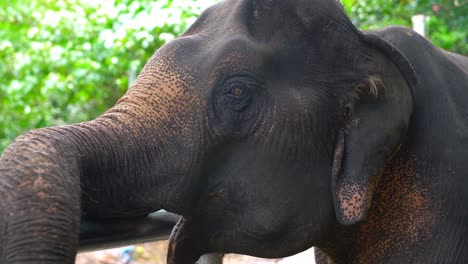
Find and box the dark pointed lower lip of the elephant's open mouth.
[167,218,206,264]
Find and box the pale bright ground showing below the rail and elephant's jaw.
[76,241,315,264]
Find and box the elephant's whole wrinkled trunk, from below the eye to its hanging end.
[0,81,203,263]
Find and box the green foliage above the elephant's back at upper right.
[341,0,468,55]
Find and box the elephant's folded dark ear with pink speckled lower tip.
[332,75,412,225]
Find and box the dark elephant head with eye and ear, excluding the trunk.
[168,0,416,263]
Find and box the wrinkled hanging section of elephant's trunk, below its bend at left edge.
[0,128,80,263]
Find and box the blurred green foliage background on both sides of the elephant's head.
[0,0,468,153]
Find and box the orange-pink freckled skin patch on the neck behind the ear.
[358,155,438,263]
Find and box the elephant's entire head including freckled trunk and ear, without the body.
[0,0,413,263]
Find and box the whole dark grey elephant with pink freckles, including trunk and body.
[0,0,468,264]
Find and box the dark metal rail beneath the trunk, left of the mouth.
[79,211,179,252]
